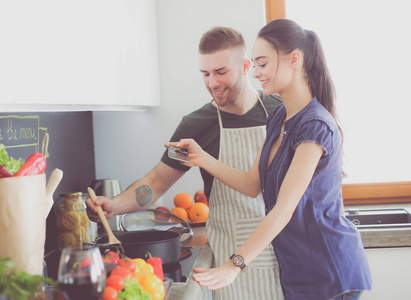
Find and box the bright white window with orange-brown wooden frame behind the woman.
[267,0,411,202]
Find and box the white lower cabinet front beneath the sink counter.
[361,247,411,300]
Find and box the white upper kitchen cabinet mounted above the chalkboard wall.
[0,0,160,111]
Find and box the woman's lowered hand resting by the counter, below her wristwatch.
[193,260,241,290]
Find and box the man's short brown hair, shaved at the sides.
[198,26,245,54]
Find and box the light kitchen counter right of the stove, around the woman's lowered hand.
[168,227,213,300]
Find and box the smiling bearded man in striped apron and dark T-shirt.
[87,27,283,300]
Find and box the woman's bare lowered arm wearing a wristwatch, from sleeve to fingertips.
[193,143,323,289]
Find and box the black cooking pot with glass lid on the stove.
[96,209,193,265]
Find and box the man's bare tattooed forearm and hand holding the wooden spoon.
[86,161,185,221]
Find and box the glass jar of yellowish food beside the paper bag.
[55,192,93,248]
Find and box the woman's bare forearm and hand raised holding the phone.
[165,139,261,198]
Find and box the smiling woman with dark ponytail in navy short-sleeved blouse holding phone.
[170,19,371,300]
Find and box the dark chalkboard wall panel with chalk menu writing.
[0,112,95,252]
